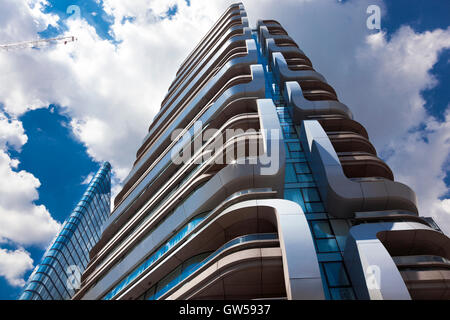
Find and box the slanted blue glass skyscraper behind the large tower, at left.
[19,162,111,300]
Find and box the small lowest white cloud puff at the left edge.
[0,248,33,287]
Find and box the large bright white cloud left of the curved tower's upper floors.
[0,0,226,180]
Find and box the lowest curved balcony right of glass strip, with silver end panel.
[344,222,450,300]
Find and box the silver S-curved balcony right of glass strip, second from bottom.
[301,120,418,218]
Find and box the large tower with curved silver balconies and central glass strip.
[74,4,450,300]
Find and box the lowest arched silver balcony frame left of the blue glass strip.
[93,199,324,299]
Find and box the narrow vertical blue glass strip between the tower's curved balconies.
[254,33,355,300]
